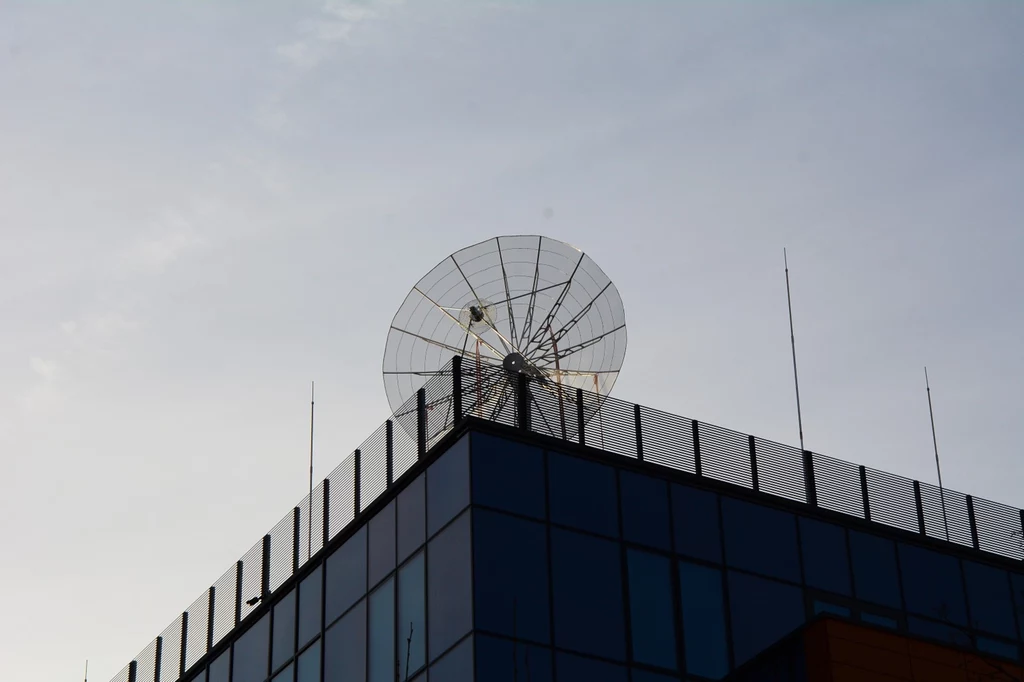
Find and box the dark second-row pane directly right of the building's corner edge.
[473,510,551,643]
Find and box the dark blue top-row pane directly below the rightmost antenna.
[899,543,967,625]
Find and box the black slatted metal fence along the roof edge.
[112,357,1024,682]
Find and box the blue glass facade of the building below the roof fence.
[196,432,1024,682]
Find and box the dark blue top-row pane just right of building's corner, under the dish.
[472,433,544,520]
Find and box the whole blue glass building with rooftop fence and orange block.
[105,364,1024,682]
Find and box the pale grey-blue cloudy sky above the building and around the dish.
[6,0,1024,682]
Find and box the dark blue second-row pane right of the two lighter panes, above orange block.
[729,570,804,666]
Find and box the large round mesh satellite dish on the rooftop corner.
[383,236,626,440]
